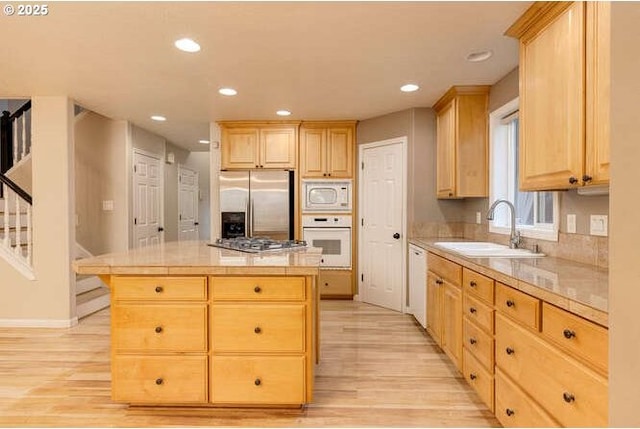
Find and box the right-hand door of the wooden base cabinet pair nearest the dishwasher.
[442,281,462,371]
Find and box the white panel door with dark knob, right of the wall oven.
[360,142,404,311]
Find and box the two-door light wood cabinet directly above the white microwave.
[300,121,356,178]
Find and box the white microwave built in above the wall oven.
[302,179,352,213]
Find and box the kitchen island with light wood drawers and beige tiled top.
[74,241,321,407]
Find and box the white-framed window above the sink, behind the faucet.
[489,98,558,241]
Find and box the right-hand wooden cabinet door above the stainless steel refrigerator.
[259,127,297,168]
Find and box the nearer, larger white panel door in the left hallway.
[133,152,164,247]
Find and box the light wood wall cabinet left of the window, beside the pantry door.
[433,85,490,198]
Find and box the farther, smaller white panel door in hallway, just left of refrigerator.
[178,167,198,241]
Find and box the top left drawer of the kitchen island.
[111,276,207,301]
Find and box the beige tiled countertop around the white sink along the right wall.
[409,238,609,326]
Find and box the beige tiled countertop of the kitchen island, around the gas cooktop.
[73,241,322,275]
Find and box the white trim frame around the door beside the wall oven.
[353,136,408,313]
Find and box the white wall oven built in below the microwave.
[302,215,351,270]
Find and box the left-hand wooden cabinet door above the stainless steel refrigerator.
[221,128,259,169]
